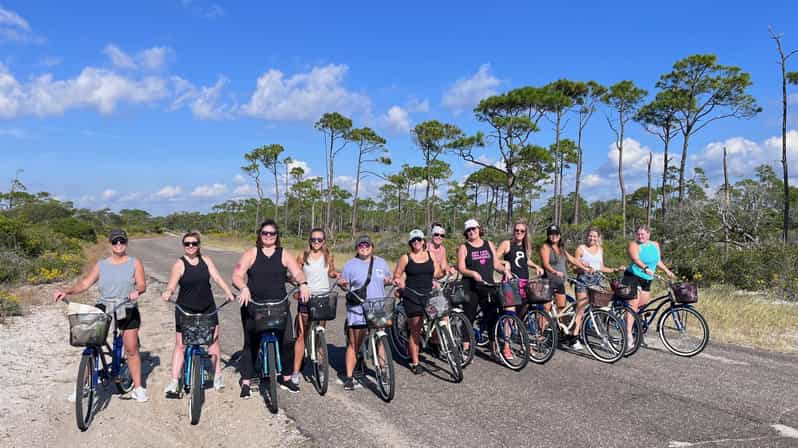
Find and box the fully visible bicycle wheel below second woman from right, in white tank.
[581,307,626,363]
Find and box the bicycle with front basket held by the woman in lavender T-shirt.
[341,286,396,402]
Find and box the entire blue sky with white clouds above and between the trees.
[0,0,798,214]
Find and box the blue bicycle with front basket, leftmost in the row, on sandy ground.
[63,298,133,431]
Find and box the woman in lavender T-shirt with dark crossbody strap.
[339,235,391,390]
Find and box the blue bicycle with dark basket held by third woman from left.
[248,286,298,414]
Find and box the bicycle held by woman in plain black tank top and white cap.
[391,288,463,383]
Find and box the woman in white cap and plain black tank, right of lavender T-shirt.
[393,229,441,375]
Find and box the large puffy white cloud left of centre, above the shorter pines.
[241,64,371,120]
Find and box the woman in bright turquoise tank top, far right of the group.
[621,225,674,340]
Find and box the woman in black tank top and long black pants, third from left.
[233,219,310,399]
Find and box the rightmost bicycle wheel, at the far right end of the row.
[657,306,709,357]
